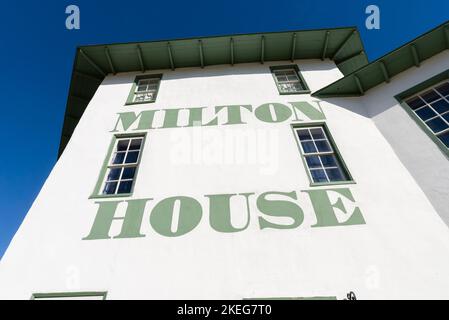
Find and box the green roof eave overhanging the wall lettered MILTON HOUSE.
[59,27,368,155]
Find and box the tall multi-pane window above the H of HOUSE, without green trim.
[102,137,143,195]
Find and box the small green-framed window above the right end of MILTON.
[271,65,310,94]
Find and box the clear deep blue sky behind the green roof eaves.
[0,0,449,257]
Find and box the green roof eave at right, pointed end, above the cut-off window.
[312,22,449,98]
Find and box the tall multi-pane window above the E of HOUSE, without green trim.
[294,125,352,184]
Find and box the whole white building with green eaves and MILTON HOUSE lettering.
[0,23,449,299]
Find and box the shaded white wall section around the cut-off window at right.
[363,50,449,225]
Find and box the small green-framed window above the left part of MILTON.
[126,74,162,104]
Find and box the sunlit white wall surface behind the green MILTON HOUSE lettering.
[0,61,449,299]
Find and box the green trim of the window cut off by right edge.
[395,69,449,159]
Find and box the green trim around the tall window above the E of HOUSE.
[290,121,356,187]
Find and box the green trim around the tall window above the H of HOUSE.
[89,132,147,199]
